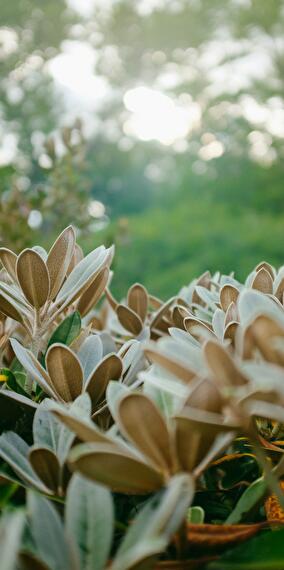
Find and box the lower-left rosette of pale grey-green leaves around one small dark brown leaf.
[0,395,91,497]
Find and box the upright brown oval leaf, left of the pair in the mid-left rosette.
[46,344,83,402]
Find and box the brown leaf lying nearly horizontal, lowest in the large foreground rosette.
[69,443,164,494]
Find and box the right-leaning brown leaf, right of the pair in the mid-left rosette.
[85,354,123,406]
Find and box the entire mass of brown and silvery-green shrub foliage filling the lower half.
[0,227,284,570]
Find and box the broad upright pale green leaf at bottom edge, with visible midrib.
[65,475,114,570]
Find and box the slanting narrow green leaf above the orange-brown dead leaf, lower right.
[226,477,267,524]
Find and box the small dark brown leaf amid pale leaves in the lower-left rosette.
[29,447,60,493]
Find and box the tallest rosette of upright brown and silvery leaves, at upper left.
[0,226,113,390]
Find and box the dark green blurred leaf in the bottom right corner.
[208,529,284,570]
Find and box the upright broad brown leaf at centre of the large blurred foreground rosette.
[117,393,175,472]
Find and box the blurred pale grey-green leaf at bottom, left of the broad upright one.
[27,491,76,570]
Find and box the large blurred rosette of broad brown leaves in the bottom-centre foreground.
[53,385,235,494]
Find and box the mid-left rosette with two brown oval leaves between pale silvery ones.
[11,334,144,419]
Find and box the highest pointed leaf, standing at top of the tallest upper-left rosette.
[46,226,76,300]
